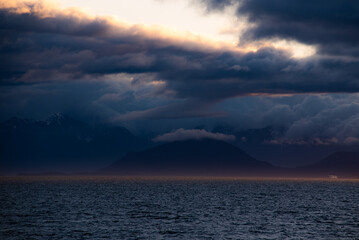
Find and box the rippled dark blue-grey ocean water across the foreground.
[0,179,359,240]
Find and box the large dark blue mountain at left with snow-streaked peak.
[0,114,147,172]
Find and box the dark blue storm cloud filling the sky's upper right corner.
[201,0,359,57]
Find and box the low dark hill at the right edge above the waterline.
[295,152,359,178]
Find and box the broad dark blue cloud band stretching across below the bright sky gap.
[0,2,359,96]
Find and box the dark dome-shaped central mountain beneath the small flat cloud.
[104,139,279,176]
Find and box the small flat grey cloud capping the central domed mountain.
[153,128,236,142]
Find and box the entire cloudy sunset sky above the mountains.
[0,0,359,165]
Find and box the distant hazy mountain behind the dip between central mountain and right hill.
[212,125,358,168]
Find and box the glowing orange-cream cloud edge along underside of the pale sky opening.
[0,0,315,58]
